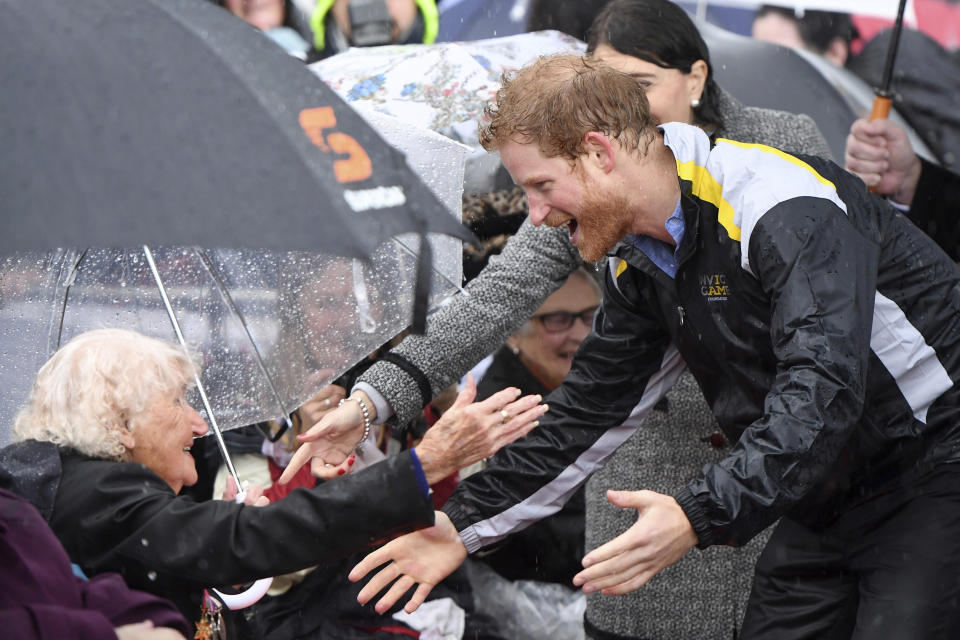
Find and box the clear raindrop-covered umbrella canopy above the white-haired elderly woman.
[0,239,456,444]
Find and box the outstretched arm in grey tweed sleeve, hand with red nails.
[280,221,583,482]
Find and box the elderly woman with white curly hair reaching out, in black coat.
[0,329,546,632]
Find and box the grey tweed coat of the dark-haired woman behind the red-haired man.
[358,91,831,640]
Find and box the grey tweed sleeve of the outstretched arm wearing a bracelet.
[357,219,583,427]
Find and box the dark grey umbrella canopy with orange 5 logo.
[0,0,468,257]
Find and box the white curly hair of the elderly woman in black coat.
[13,329,196,461]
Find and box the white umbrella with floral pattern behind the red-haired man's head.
[310,31,586,147]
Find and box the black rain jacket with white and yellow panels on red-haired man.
[444,123,960,551]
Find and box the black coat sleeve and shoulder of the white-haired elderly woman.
[0,443,433,617]
